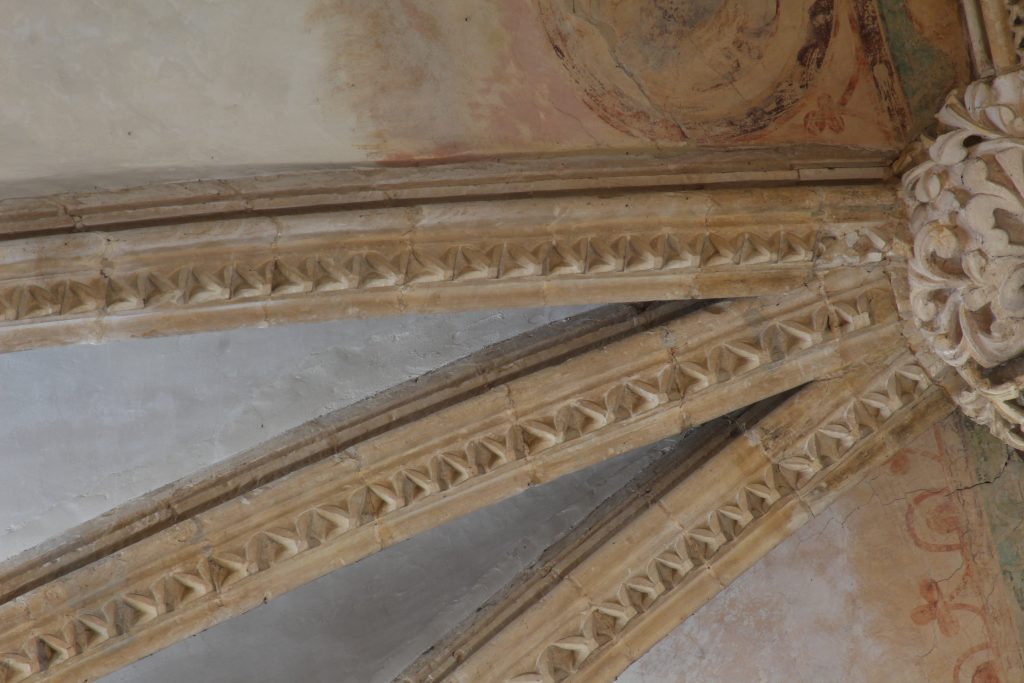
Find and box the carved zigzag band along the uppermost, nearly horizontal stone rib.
[0,231,816,322]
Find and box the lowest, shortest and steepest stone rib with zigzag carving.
[396,351,952,683]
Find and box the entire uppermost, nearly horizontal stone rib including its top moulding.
[0,147,899,352]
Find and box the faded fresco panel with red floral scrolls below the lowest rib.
[620,416,1024,683]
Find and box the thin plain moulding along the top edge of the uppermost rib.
[0,145,892,241]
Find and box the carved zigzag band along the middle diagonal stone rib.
[0,290,892,683]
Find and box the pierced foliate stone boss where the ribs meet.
[903,65,1024,449]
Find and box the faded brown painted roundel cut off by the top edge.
[538,0,836,141]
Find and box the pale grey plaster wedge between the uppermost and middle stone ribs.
[0,308,582,560]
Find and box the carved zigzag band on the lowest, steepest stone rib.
[509,365,931,683]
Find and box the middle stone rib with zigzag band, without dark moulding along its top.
[0,268,902,683]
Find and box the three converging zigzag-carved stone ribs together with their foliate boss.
[0,3,1024,683]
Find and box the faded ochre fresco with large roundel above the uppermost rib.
[308,0,969,159]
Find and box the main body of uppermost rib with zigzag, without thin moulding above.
[0,179,897,352]
